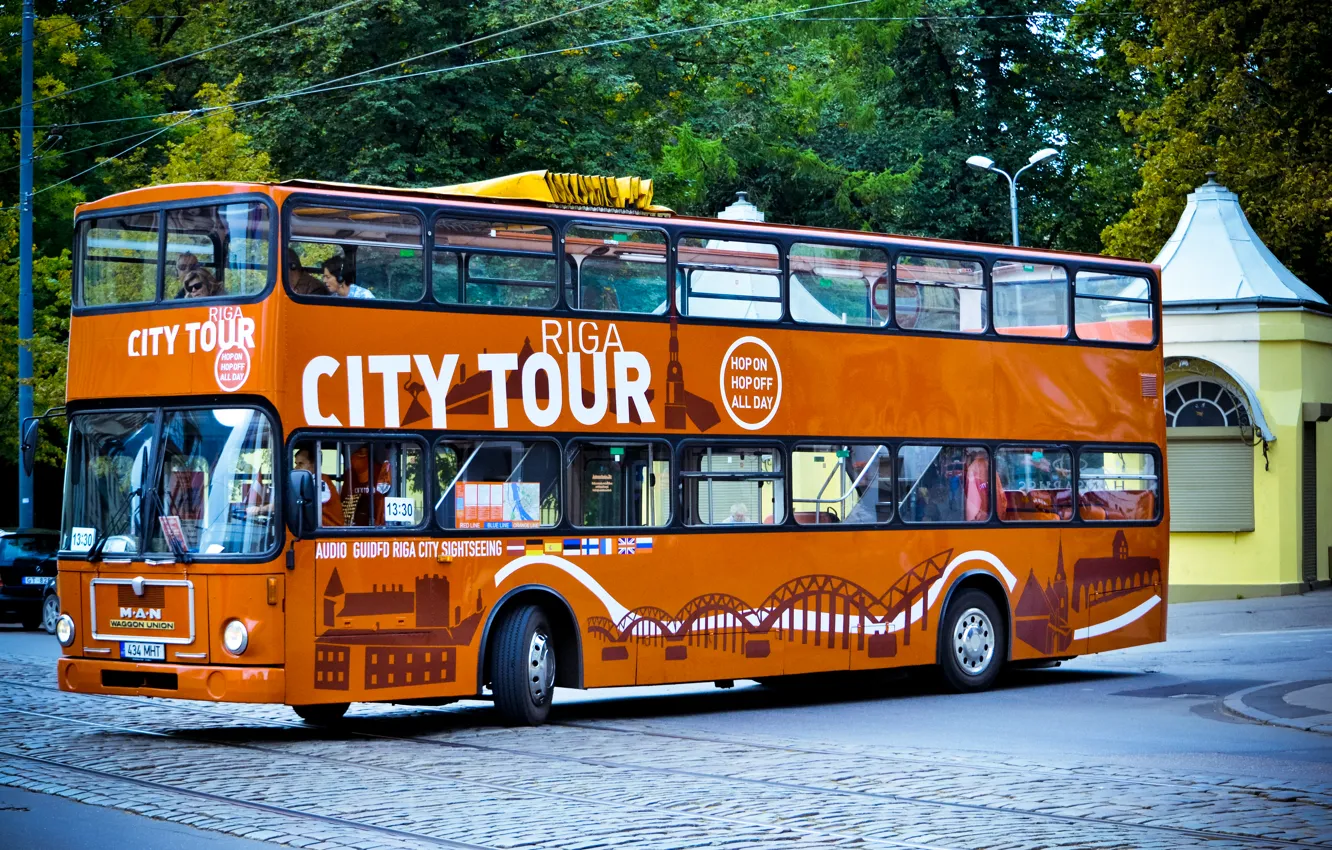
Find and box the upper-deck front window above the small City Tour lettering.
[79,203,270,306]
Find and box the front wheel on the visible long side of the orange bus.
[489,605,555,726]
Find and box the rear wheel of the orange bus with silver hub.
[939,588,1008,693]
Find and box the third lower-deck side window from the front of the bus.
[569,442,670,528]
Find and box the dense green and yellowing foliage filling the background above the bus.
[0,0,1332,482]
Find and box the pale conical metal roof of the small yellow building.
[1154,175,1327,304]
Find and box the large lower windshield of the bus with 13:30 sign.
[61,408,280,556]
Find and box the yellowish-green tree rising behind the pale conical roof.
[1103,0,1332,300]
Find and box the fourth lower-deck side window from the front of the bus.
[681,445,786,525]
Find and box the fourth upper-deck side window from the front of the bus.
[677,236,782,321]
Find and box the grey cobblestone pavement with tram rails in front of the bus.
[0,654,1332,850]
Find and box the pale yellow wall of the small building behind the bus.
[1166,310,1332,600]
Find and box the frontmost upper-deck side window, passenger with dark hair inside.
[288,205,425,301]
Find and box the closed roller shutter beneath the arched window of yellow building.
[1166,437,1253,532]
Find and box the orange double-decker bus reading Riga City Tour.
[44,172,1167,723]
